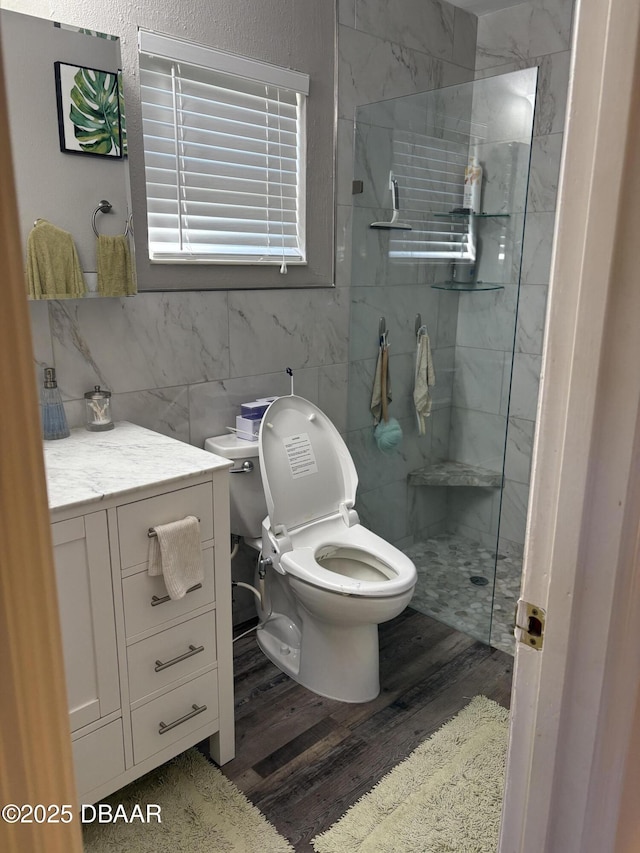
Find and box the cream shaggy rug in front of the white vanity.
[84,749,293,853]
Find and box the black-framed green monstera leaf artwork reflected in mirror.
[54,62,122,159]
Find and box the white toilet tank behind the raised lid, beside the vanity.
[204,433,267,539]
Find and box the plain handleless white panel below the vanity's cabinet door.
[71,720,125,802]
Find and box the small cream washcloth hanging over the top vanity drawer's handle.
[149,515,204,601]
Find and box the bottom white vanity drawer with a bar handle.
[131,670,218,764]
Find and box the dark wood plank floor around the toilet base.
[222,609,513,853]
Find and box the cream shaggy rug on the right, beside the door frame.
[312,696,509,853]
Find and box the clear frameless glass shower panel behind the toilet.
[347,69,537,651]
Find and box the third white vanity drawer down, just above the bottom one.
[127,610,216,702]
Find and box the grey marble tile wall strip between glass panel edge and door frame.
[476,0,574,553]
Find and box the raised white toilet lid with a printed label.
[259,395,358,531]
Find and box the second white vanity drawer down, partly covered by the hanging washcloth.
[122,548,215,637]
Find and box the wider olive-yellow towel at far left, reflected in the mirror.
[26,219,87,299]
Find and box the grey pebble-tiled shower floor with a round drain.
[404,533,522,654]
